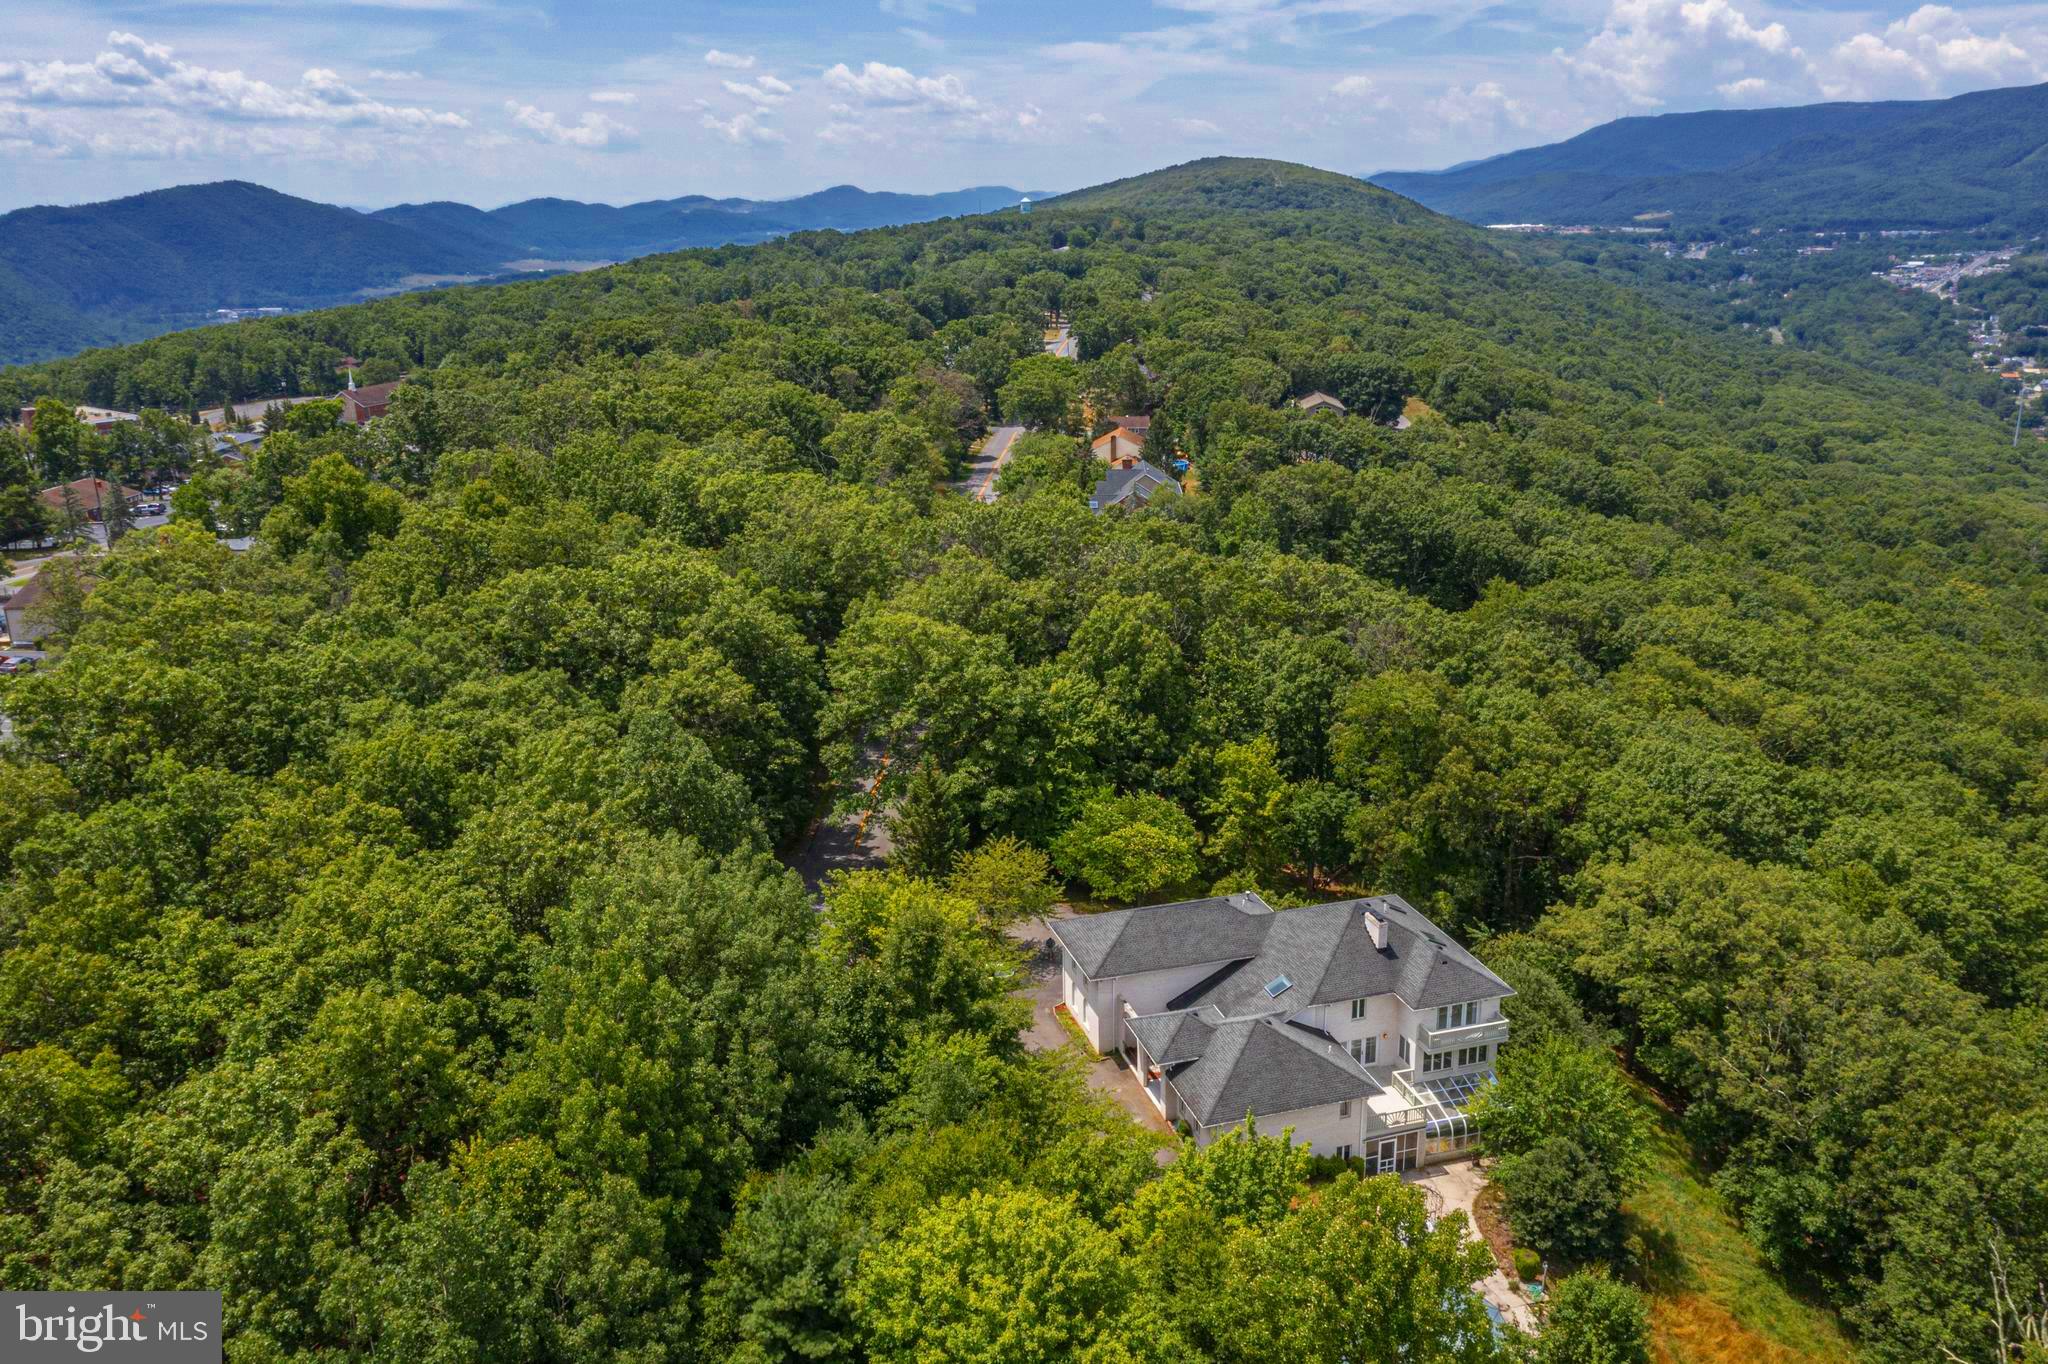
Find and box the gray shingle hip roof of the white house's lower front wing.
[1171,1018,1380,1126]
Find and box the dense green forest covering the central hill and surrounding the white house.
[0,162,2048,1364]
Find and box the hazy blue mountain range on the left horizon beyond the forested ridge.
[0,180,1044,363]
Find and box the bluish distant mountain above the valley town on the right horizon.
[1374,86,2048,231]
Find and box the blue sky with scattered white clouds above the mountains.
[0,0,2048,209]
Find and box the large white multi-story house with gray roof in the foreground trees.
[1051,891,1513,1171]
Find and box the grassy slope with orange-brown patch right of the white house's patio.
[1628,1092,1855,1364]
